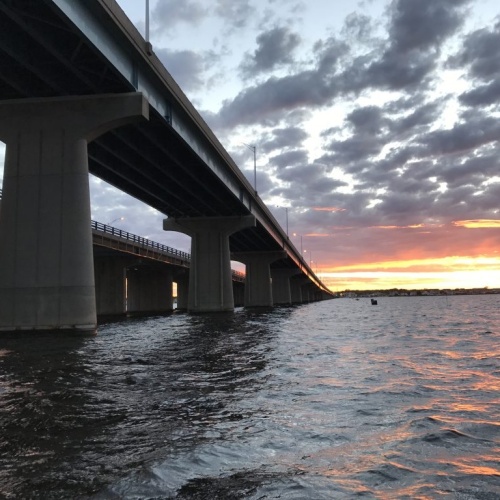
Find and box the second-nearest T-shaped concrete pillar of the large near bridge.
[163,215,255,312]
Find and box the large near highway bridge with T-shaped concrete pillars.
[0,0,330,331]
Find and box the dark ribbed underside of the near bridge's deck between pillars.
[0,0,294,267]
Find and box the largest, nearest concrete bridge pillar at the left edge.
[0,94,149,332]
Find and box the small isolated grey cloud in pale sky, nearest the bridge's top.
[240,26,300,77]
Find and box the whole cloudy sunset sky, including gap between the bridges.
[0,0,500,291]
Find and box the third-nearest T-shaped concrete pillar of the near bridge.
[232,250,286,307]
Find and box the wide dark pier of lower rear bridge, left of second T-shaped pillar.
[127,264,174,314]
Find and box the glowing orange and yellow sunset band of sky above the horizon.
[295,220,500,291]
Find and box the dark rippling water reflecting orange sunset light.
[0,295,500,500]
